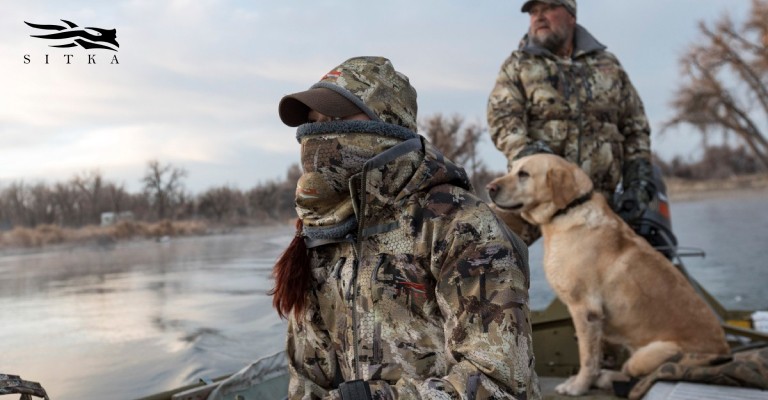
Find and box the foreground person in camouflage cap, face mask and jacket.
[281,57,540,400]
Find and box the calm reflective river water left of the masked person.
[0,228,291,400]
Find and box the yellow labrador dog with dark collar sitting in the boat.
[488,154,729,396]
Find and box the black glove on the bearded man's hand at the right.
[615,160,656,223]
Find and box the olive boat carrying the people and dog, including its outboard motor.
[135,177,768,400]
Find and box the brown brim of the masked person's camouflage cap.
[278,88,363,127]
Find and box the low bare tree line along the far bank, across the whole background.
[0,114,764,230]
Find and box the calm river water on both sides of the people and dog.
[0,192,768,400]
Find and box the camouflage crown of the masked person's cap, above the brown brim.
[311,57,417,132]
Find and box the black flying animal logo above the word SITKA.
[24,19,120,51]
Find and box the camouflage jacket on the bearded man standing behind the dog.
[488,25,650,198]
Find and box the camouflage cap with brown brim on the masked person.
[279,57,417,132]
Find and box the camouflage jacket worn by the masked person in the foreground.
[287,137,539,399]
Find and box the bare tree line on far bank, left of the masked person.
[0,160,299,230]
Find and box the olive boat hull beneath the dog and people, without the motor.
[129,277,768,400]
